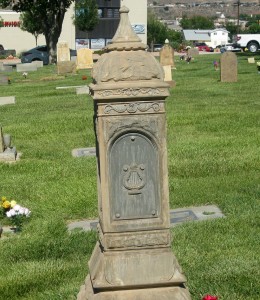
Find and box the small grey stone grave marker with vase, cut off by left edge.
[0,126,17,162]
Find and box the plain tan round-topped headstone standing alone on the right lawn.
[220,52,237,82]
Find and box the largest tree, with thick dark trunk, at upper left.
[0,0,74,62]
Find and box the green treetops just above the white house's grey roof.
[180,16,214,29]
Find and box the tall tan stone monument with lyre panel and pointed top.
[77,6,191,300]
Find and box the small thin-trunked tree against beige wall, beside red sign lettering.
[20,11,43,46]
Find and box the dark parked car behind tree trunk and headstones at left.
[21,46,77,65]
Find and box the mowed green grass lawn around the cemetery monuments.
[0,54,260,300]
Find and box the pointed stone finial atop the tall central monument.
[106,6,147,51]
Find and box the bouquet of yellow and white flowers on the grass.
[1,197,31,232]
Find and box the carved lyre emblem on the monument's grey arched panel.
[123,163,146,195]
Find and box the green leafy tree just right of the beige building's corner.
[147,11,183,48]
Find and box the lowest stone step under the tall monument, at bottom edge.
[77,276,191,300]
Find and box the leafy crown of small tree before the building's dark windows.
[73,0,99,31]
